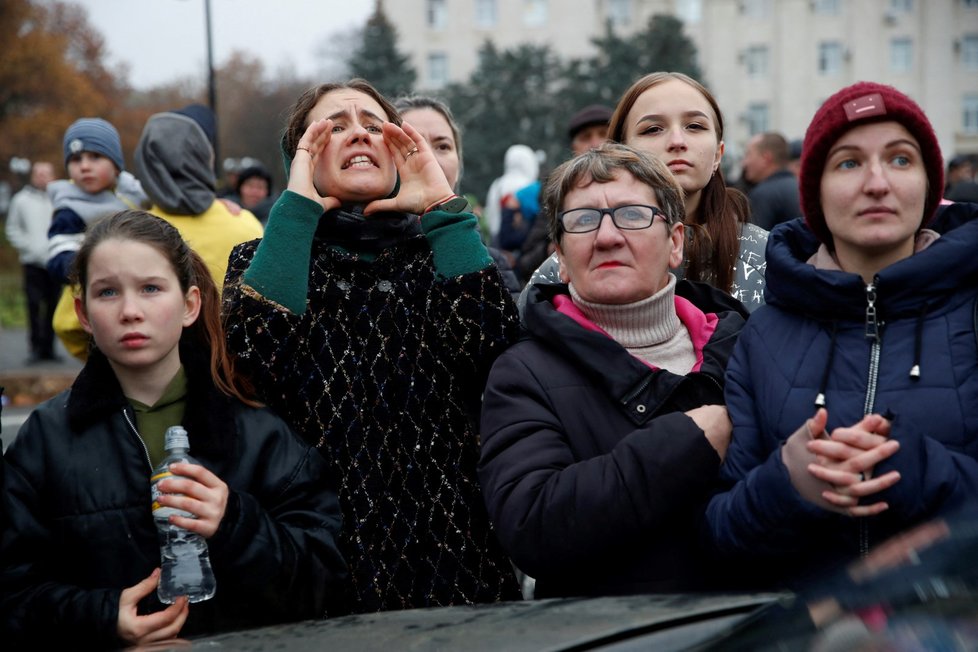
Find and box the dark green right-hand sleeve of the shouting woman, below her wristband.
[421,211,492,278]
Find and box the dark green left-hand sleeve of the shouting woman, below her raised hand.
[242,190,323,315]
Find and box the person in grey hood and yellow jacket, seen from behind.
[135,104,263,288]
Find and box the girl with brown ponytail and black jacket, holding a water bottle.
[0,211,345,647]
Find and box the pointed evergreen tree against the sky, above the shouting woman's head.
[348,0,417,99]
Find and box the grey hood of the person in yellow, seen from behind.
[135,112,217,215]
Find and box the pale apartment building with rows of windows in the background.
[386,0,978,159]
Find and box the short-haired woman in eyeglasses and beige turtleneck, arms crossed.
[479,143,747,597]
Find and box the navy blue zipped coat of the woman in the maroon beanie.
[707,211,978,587]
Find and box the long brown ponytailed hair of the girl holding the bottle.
[71,210,259,406]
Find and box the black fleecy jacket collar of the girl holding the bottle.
[67,337,237,457]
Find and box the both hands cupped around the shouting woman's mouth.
[288,118,453,215]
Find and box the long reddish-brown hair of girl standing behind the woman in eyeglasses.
[608,72,750,292]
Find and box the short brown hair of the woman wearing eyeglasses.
[542,142,686,243]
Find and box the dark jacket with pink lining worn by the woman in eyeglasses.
[479,281,746,597]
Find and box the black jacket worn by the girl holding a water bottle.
[0,351,346,649]
